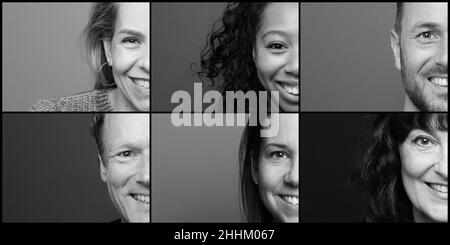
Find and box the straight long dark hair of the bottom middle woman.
[239,123,273,223]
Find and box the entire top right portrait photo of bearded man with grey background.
[300,2,448,112]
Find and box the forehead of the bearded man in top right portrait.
[403,3,448,26]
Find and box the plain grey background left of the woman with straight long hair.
[151,114,244,222]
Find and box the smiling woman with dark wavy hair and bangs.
[360,113,448,222]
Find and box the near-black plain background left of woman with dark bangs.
[300,113,375,222]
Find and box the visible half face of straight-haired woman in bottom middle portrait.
[253,114,299,222]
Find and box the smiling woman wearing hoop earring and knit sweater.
[30,2,150,112]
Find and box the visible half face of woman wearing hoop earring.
[104,3,150,111]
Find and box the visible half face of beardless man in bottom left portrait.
[100,114,150,222]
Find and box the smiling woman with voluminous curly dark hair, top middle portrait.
[198,2,299,111]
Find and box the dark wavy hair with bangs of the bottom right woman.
[358,113,447,222]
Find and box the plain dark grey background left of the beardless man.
[2,113,120,222]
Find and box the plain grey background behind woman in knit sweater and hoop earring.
[2,3,94,111]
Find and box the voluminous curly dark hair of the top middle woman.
[197,2,267,94]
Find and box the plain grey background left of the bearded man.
[300,3,405,111]
